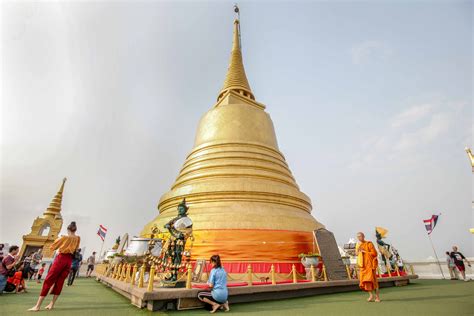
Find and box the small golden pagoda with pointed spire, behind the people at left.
[20,178,66,258]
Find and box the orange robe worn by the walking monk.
[358,241,379,291]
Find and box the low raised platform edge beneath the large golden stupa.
[97,275,418,311]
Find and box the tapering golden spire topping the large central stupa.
[217,19,255,101]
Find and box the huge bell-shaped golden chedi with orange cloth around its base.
[142,20,323,272]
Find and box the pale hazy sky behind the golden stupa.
[0,1,474,260]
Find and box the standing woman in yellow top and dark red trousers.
[29,222,81,312]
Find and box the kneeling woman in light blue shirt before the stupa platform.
[198,255,229,313]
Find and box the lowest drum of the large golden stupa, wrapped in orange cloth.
[143,200,323,275]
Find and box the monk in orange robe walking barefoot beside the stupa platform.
[356,232,380,302]
